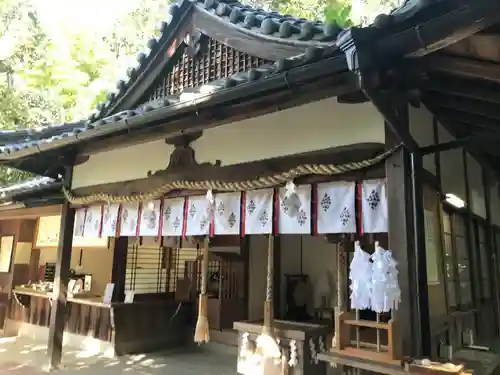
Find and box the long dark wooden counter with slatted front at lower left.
[4,288,193,355]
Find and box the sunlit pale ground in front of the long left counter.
[0,337,236,375]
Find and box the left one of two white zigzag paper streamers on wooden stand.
[349,241,372,310]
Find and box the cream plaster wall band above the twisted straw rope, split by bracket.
[73,98,385,188]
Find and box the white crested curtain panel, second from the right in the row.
[316,181,356,234]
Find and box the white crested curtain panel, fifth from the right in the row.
[214,193,241,235]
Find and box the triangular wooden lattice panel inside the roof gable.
[147,38,268,102]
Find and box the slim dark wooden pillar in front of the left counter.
[47,165,75,369]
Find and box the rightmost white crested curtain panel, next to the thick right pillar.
[361,179,389,233]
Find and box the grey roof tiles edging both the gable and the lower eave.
[0,0,448,160]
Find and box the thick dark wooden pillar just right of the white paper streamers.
[385,101,430,356]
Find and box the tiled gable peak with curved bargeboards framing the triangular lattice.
[90,0,342,122]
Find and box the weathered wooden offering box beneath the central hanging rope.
[234,320,331,375]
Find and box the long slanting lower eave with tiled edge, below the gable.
[0,46,347,163]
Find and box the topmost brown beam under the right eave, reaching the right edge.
[423,54,500,83]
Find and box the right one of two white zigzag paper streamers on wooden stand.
[371,242,401,313]
